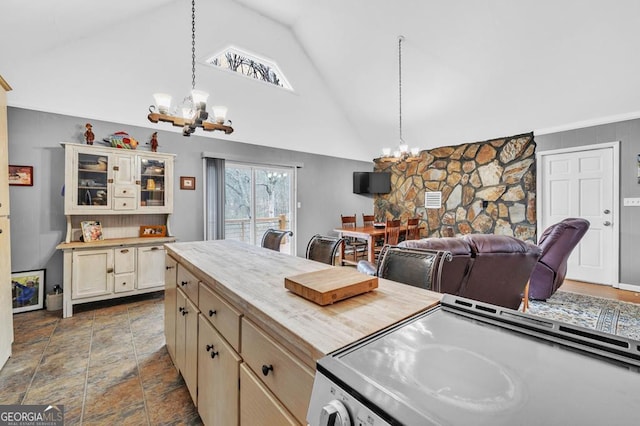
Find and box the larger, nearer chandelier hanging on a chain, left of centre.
[147,0,233,136]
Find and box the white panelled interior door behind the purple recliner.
[538,143,619,286]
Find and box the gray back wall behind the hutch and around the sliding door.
[8,107,373,291]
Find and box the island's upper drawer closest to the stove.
[242,317,314,423]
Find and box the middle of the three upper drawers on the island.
[198,282,242,352]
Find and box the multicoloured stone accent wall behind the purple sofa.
[374,133,536,242]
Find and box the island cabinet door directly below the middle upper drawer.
[198,313,242,425]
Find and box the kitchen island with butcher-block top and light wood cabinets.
[165,240,441,424]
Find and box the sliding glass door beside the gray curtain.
[224,162,295,254]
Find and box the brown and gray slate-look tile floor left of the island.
[0,292,202,425]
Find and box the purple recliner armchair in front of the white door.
[529,218,589,300]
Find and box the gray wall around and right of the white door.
[535,119,640,285]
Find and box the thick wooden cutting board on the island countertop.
[284,267,378,306]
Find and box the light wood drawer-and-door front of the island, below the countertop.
[165,256,314,425]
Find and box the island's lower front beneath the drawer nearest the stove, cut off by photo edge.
[240,363,300,426]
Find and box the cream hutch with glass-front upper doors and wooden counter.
[57,143,175,318]
